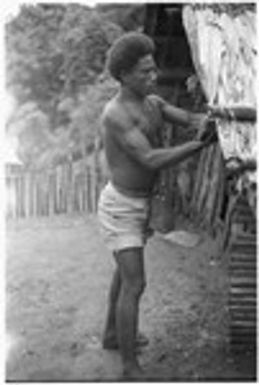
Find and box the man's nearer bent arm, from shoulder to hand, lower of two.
[103,107,209,170]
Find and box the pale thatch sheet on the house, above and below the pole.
[183,4,257,186]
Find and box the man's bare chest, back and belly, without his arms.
[103,95,163,196]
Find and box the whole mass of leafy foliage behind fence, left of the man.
[6,4,129,167]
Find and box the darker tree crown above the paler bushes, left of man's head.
[6,4,121,124]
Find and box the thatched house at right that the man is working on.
[145,3,257,351]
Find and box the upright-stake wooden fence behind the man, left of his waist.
[6,162,106,218]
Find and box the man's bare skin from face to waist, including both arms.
[103,56,208,196]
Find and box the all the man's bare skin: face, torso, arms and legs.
[102,55,214,379]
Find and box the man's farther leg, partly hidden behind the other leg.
[103,267,121,349]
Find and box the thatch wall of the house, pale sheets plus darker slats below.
[183,4,257,237]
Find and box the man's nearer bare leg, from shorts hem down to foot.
[115,248,145,378]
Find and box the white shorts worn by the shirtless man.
[98,182,150,251]
